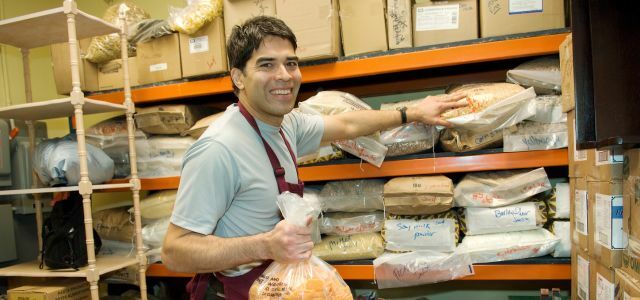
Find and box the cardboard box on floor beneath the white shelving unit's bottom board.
[7,279,91,300]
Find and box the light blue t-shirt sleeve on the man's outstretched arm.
[288,111,324,157]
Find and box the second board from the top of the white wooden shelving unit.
[0,98,127,120]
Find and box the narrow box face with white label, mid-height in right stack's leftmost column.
[569,178,593,253]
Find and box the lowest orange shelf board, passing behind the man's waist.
[147,264,571,280]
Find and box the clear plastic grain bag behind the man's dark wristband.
[380,99,440,157]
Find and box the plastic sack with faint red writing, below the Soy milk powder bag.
[373,250,474,289]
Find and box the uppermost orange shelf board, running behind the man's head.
[89,33,567,103]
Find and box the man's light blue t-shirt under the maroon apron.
[171,105,324,237]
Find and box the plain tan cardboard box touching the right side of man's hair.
[276,0,341,61]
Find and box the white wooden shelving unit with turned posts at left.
[0,0,147,300]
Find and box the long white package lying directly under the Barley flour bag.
[458,228,559,264]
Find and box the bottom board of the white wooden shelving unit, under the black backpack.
[0,256,138,277]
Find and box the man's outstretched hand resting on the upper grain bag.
[407,93,468,127]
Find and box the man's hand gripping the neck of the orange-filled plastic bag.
[267,218,313,263]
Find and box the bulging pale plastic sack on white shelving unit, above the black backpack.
[33,136,114,186]
